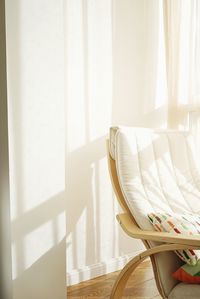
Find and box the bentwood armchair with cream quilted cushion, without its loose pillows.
[107,127,200,299]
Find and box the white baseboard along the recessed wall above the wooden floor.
[67,250,142,286]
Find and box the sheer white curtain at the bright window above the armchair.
[163,0,200,127]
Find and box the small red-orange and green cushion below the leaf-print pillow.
[173,261,200,283]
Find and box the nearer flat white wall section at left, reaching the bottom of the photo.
[6,0,66,299]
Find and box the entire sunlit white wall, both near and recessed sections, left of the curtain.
[4,0,170,292]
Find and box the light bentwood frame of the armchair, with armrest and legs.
[106,140,200,299]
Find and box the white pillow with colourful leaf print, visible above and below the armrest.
[148,213,200,265]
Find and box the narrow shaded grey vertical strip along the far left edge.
[0,1,12,299]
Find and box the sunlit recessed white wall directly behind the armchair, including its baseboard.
[66,0,170,284]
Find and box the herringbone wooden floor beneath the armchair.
[67,261,161,299]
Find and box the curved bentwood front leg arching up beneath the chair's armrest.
[110,244,196,299]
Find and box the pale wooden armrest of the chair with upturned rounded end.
[117,213,200,247]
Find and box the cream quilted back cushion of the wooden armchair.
[113,128,200,230]
